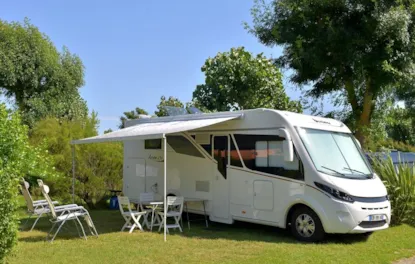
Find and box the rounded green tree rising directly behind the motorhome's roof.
[193,47,302,112]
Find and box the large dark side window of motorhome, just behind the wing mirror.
[234,134,304,180]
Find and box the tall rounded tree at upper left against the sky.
[0,19,88,126]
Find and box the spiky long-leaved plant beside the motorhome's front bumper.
[373,156,415,225]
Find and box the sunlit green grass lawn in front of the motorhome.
[7,208,415,264]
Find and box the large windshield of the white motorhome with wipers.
[298,128,372,179]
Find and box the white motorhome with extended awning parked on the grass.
[74,109,391,241]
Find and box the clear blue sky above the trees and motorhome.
[0,0,328,133]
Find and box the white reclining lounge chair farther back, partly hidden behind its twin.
[20,178,76,231]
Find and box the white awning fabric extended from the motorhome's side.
[71,116,240,145]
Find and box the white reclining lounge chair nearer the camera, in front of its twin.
[41,183,98,242]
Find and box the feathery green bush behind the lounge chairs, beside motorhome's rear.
[31,113,123,207]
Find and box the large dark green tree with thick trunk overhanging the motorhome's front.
[250,0,415,145]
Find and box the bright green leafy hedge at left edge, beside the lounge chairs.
[0,104,54,262]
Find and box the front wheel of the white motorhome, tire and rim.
[291,206,325,242]
